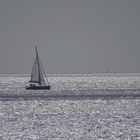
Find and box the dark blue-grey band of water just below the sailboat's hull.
[0,89,140,101]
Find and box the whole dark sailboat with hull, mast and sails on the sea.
[26,46,50,90]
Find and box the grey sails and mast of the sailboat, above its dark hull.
[30,46,47,86]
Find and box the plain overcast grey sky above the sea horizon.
[0,0,140,73]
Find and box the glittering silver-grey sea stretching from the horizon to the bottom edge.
[0,73,140,140]
